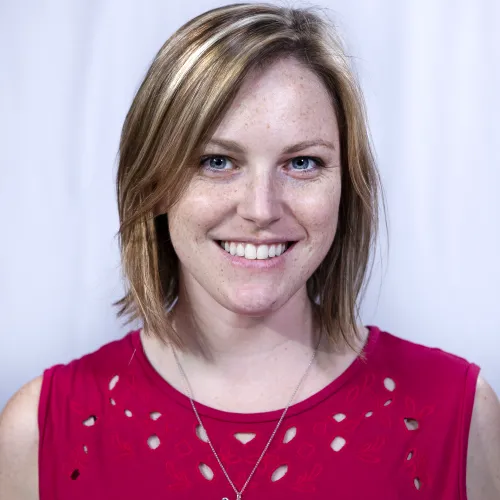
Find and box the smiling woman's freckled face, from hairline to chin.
[168,59,341,316]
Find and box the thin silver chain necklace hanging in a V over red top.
[172,335,321,500]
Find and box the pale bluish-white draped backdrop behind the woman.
[0,0,500,407]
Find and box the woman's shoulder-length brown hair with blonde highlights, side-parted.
[114,3,381,347]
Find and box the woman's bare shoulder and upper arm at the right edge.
[467,376,500,500]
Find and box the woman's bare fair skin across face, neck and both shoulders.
[0,60,500,500]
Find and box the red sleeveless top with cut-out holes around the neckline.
[39,326,479,500]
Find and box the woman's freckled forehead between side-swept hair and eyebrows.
[214,58,338,147]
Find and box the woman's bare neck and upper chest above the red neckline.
[142,284,367,413]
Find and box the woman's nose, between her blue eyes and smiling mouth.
[237,169,283,228]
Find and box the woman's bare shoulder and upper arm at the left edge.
[0,376,42,500]
